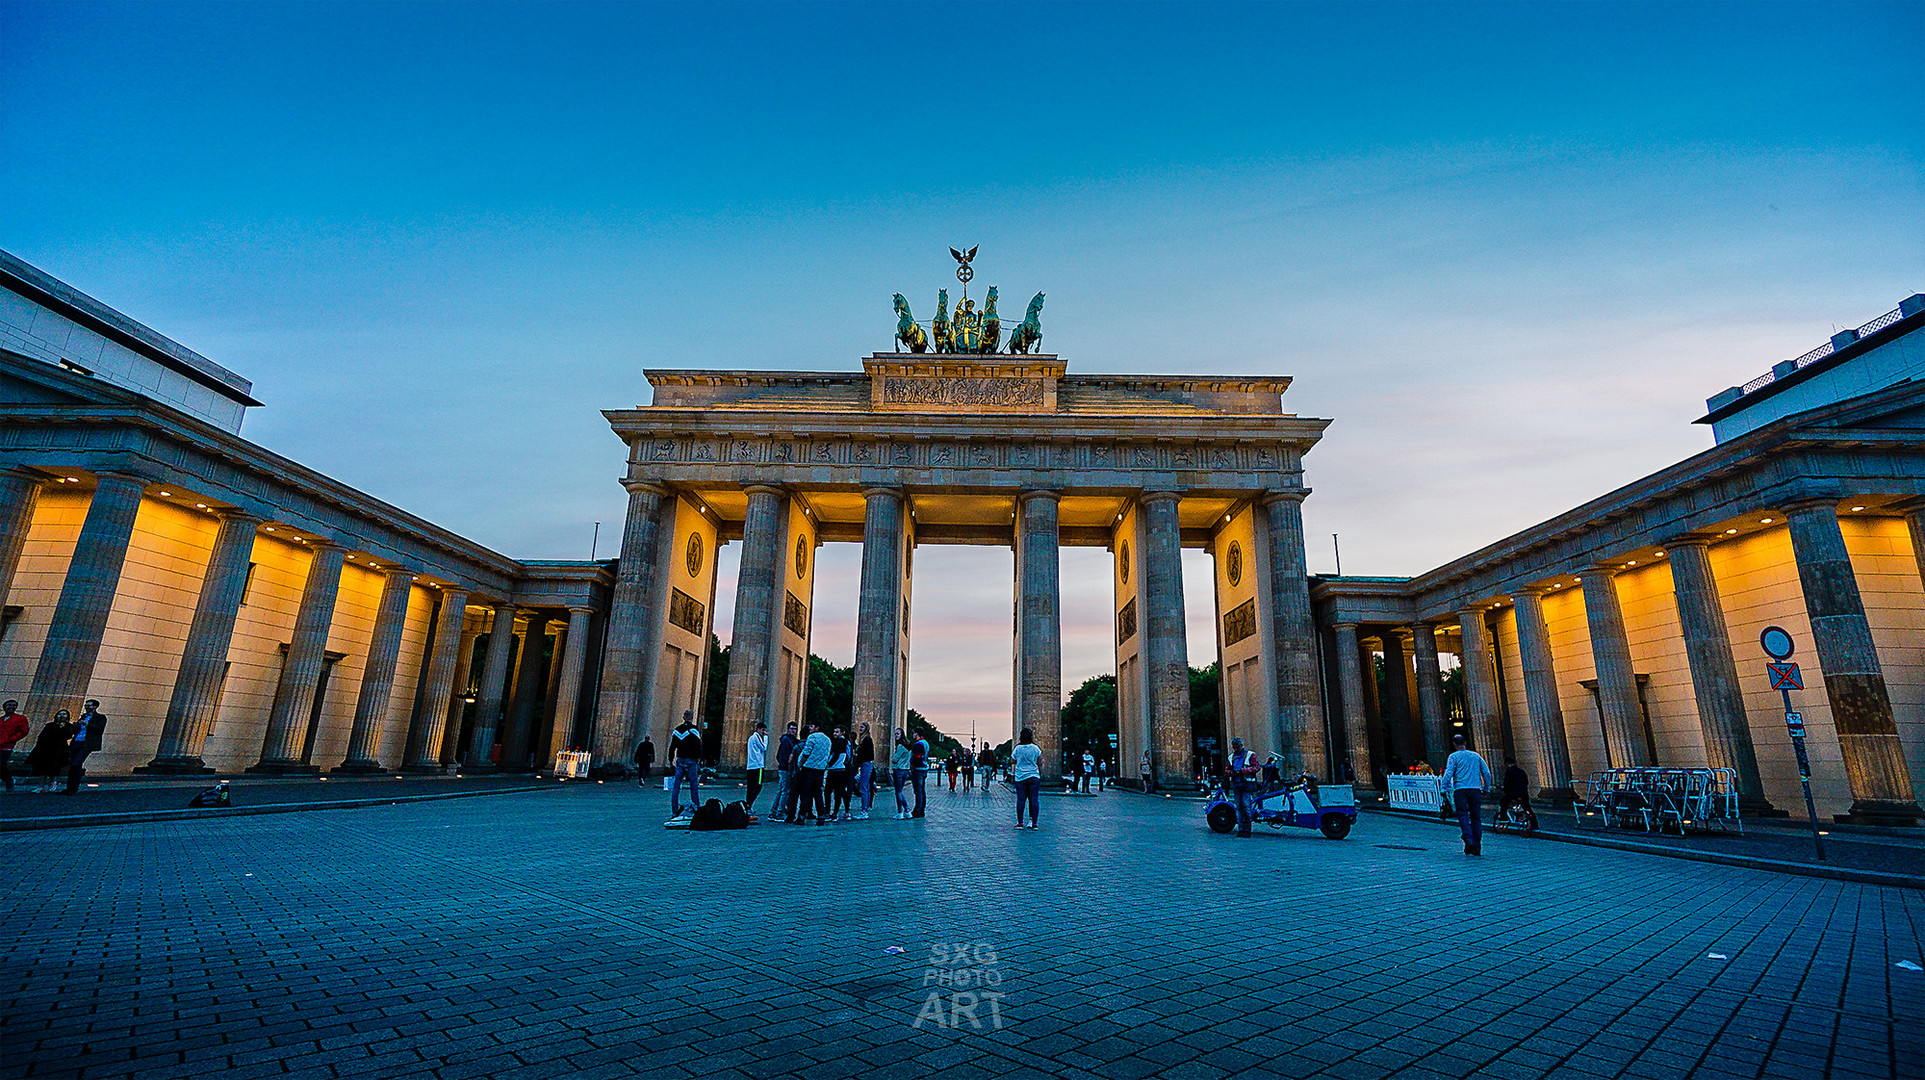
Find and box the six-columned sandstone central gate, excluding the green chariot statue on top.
[593,350,1328,785]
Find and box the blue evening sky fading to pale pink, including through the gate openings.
[0,2,1925,739]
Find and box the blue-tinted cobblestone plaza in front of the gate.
[0,784,1925,1080]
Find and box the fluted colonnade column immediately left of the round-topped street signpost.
[1665,537,1773,814]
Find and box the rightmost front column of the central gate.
[1263,491,1330,778]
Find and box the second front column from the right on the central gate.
[1142,491,1195,787]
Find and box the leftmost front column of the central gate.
[591,479,674,768]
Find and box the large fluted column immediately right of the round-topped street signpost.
[1788,501,1925,826]
